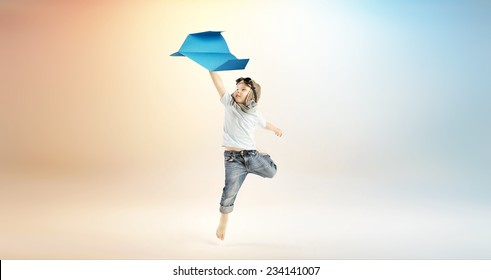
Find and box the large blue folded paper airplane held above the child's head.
[171,31,249,71]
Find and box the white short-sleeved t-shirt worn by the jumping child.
[220,93,266,150]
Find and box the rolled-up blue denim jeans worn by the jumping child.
[220,150,277,214]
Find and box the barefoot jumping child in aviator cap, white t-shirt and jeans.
[210,71,283,240]
